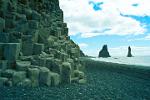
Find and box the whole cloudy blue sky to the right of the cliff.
[59,0,150,56]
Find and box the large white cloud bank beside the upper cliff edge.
[60,0,150,38]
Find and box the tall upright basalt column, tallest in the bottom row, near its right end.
[61,62,71,83]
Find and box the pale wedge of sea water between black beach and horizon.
[91,56,150,67]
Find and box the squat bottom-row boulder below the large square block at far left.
[12,71,26,85]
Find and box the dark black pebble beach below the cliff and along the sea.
[0,59,150,100]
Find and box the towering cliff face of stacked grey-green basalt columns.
[0,0,85,87]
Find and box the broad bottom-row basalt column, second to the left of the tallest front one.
[39,67,51,86]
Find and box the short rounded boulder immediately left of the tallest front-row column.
[50,72,61,86]
